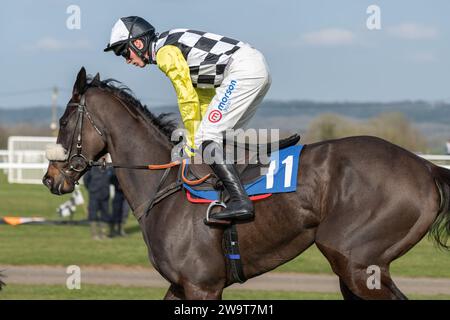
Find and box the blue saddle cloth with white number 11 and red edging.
[183,145,303,203]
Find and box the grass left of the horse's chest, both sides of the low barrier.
[0,174,149,265]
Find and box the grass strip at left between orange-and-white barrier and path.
[0,225,149,266]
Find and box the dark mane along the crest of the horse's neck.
[88,77,177,141]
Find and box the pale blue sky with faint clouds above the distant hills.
[0,0,450,108]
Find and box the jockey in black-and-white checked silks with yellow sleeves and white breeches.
[104,16,271,220]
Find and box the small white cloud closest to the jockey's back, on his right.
[302,28,355,46]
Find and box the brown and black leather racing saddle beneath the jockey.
[184,134,300,190]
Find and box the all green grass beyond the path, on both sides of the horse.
[0,173,450,278]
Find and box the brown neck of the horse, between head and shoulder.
[107,119,171,210]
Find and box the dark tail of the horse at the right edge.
[429,166,450,251]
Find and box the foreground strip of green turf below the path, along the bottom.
[0,284,450,300]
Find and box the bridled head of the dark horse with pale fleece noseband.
[42,67,106,195]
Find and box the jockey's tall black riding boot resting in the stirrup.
[204,141,254,220]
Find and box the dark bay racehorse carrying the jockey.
[43,68,450,299]
